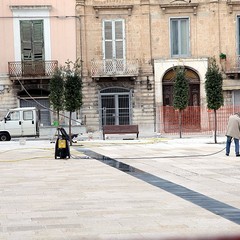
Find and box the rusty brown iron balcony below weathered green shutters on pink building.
[8,60,58,80]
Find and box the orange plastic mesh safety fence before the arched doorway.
[158,106,236,135]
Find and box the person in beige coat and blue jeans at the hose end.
[226,113,240,157]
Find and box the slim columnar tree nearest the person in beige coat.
[205,58,223,143]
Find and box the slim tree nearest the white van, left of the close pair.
[49,68,64,124]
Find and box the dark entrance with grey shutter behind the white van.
[18,89,51,126]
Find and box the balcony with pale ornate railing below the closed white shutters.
[91,59,139,78]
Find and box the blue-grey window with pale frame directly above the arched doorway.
[170,18,189,57]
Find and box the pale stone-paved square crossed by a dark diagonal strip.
[0,137,240,240]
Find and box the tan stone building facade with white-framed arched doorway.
[76,0,240,134]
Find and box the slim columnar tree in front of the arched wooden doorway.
[173,67,189,138]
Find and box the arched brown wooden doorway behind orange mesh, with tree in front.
[162,67,200,132]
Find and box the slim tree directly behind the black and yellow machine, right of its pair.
[64,61,82,145]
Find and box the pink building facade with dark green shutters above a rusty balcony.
[0,0,79,126]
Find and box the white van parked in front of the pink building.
[0,107,39,141]
